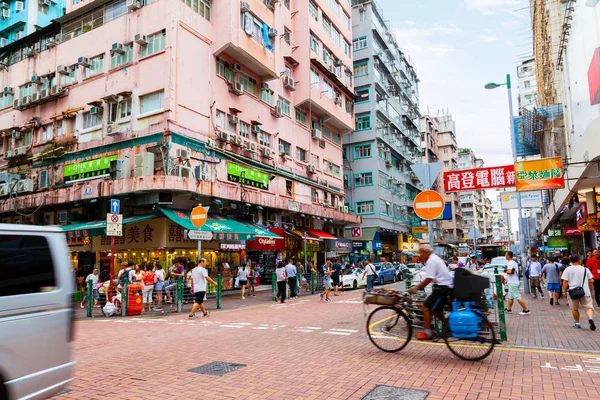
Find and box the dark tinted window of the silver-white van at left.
[0,235,56,297]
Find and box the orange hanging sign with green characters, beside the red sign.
[515,157,565,192]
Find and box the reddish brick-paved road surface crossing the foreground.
[57,282,600,400]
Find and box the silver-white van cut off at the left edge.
[0,224,75,400]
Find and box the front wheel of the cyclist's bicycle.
[367,306,412,353]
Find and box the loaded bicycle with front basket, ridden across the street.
[364,291,497,361]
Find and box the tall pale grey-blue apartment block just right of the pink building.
[344,1,421,258]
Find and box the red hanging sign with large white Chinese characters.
[444,165,515,193]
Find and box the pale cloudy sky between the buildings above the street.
[375,0,532,234]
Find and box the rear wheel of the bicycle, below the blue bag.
[443,315,496,361]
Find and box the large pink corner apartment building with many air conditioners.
[0,0,359,272]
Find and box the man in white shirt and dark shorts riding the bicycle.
[409,244,454,340]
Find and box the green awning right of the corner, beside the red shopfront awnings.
[158,207,256,240]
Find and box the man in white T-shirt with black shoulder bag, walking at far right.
[562,254,596,331]
